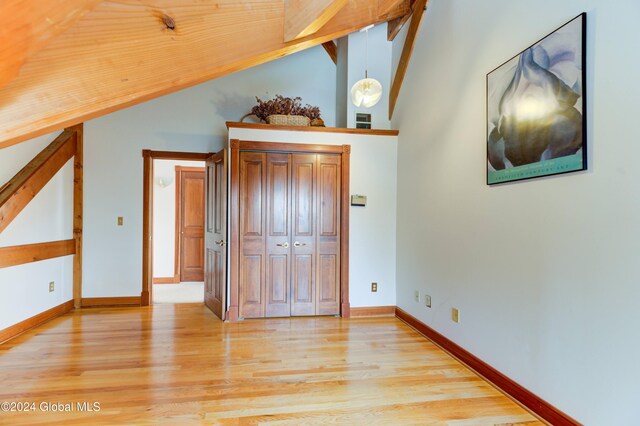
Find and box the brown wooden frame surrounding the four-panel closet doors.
[226,139,351,322]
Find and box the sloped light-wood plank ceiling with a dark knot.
[0,0,411,148]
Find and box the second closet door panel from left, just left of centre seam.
[265,154,291,317]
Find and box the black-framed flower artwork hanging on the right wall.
[487,13,587,185]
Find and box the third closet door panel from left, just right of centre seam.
[291,154,317,316]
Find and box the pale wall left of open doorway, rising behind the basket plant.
[83,47,336,297]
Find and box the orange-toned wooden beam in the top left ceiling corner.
[0,0,100,87]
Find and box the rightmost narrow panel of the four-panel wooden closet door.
[316,155,342,315]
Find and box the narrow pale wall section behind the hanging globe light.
[347,24,393,129]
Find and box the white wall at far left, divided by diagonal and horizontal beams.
[0,133,73,330]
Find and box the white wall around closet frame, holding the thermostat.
[229,128,398,307]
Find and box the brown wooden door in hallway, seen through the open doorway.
[178,168,204,281]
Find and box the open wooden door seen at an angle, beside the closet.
[204,150,227,320]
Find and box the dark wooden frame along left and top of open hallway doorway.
[140,149,213,306]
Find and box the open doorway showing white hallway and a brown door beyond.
[152,159,205,304]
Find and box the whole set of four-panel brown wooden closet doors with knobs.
[238,152,341,318]
